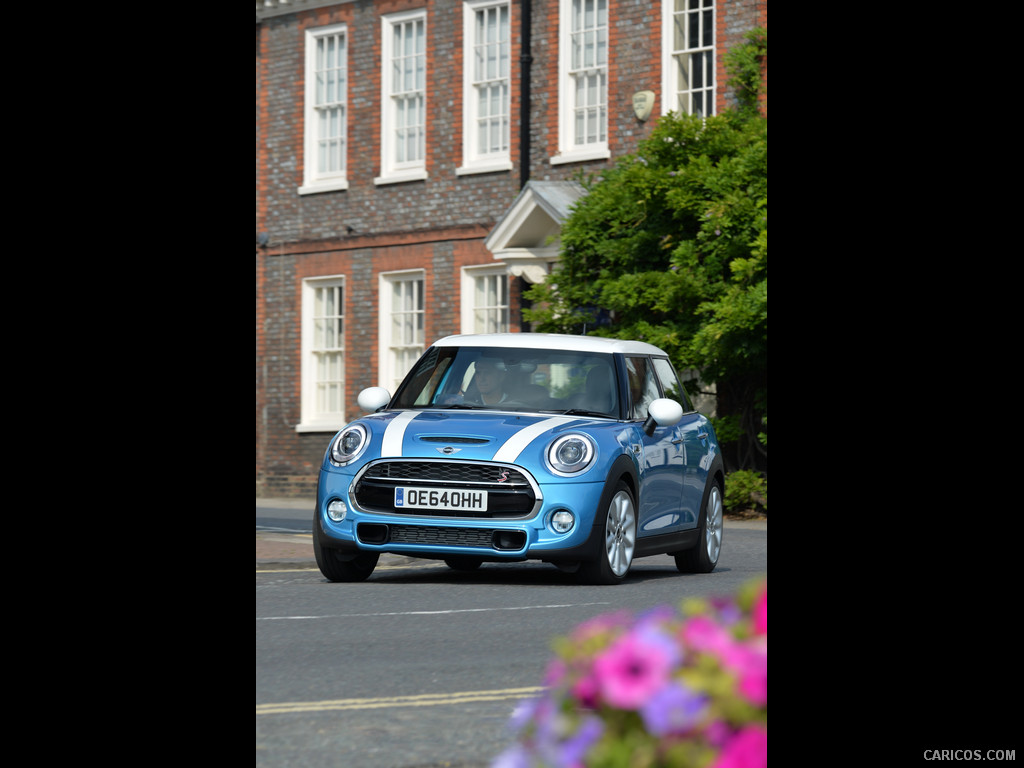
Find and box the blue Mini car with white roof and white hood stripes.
[312,333,725,585]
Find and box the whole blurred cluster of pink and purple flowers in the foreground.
[492,581,768,768]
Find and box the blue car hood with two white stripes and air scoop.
[362,411,606,463]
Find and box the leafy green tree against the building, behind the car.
[523,36,768,469]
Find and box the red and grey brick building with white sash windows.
[256,0,767,497]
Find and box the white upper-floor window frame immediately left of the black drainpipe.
[456,0,513,176]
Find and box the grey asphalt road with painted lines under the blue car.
[256,509,768,768]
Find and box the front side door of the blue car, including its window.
[626,356,686,537]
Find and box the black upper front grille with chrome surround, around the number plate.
[353,459,540,519]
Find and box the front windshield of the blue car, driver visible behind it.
[392,346,618,418]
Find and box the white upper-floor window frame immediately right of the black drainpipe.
[549,0,611,165]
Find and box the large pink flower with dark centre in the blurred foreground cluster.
[594,629,679,710]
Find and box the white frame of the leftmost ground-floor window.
[296,274,348,432]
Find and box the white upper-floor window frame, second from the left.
[374,8,430,184]
